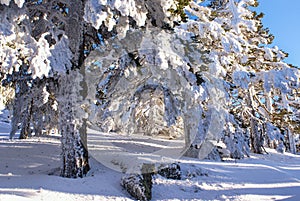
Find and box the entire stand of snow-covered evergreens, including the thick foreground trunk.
[0,0,300,178]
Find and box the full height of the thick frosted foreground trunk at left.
[58,0,90,178]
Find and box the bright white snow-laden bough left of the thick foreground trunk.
[0,9,72,79]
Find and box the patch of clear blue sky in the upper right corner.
[258,0,300,67]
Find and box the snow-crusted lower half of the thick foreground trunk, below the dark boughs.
[59,71,90,178]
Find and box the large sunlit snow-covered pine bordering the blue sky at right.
[178,0,299,156]
